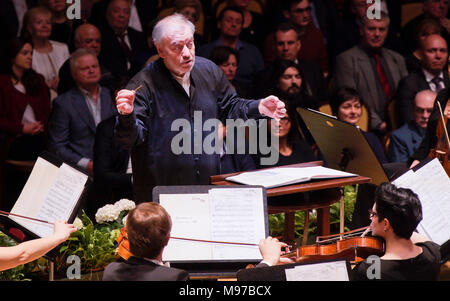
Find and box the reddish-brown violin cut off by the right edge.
[428,100,450,176]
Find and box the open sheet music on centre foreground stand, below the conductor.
[159,188,265,261]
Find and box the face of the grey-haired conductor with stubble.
[156,26,195,76]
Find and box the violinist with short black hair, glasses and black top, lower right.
[353,183,441,281]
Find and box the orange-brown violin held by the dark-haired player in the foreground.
[281,227,385,263]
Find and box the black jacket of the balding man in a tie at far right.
[395,67,450,126]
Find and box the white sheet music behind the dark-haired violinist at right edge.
[393,159,450,245]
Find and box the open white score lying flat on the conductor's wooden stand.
[226,166,356,188]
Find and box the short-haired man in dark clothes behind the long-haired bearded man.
[253,23,329,105]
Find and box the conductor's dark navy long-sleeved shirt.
[116,57,262,202]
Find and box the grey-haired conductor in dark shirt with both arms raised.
[116,14,285,202]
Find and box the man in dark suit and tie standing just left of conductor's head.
[99,0,147,82]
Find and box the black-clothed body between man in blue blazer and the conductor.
[93,115,133,208]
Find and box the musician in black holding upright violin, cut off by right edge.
[410,88,450,171]
